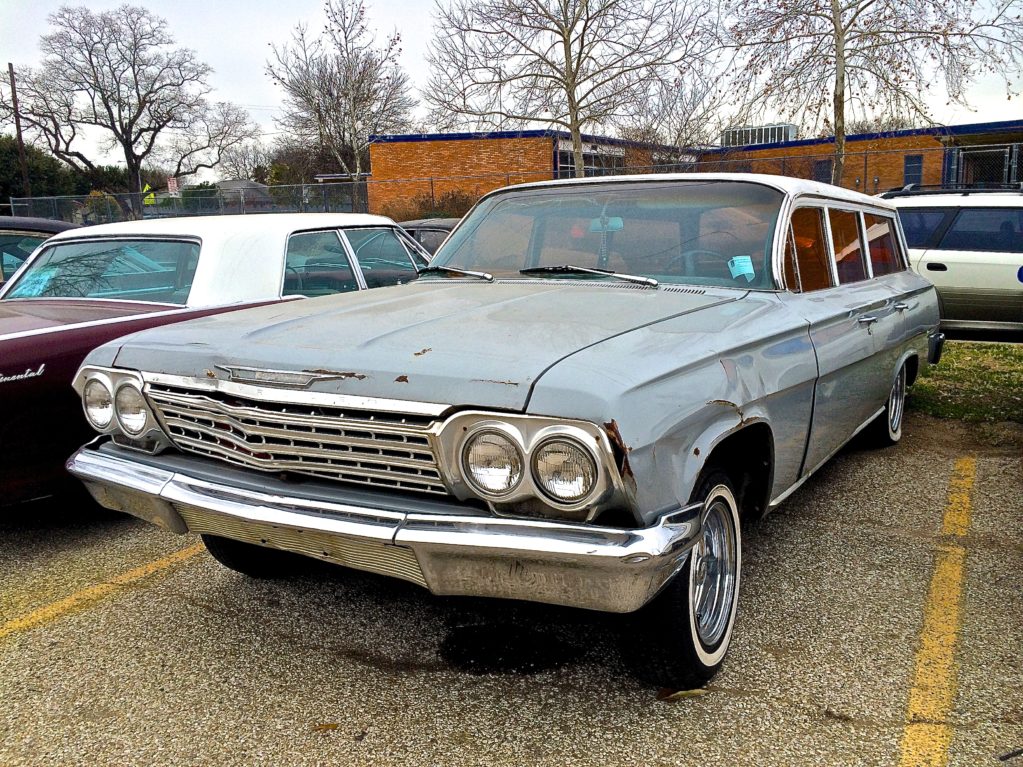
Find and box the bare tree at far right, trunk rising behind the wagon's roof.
[725,0,1023,184]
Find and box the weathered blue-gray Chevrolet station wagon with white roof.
[69,174,943,688]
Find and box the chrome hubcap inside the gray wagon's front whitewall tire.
[693,498,737,646]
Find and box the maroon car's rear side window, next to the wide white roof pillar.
[280,229,359,297]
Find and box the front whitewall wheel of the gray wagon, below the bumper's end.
[623,470,742,689]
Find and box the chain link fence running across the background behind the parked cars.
[10,144,1023,224]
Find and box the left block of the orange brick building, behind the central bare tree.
[368,130,678,219]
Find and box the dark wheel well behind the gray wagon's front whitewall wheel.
[705,423,774,520]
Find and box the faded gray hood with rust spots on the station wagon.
[105,279,744,410]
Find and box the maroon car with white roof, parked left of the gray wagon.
[0,214,427,505]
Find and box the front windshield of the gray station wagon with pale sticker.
[432,181,783,289]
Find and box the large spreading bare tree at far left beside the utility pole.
[1,5,254,213]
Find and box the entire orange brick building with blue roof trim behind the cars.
[368,120,1023,220]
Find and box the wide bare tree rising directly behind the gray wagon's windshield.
[424,0,712,176]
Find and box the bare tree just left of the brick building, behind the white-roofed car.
[266,0,415,179]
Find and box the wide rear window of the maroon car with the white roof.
[4,239,199,304]
